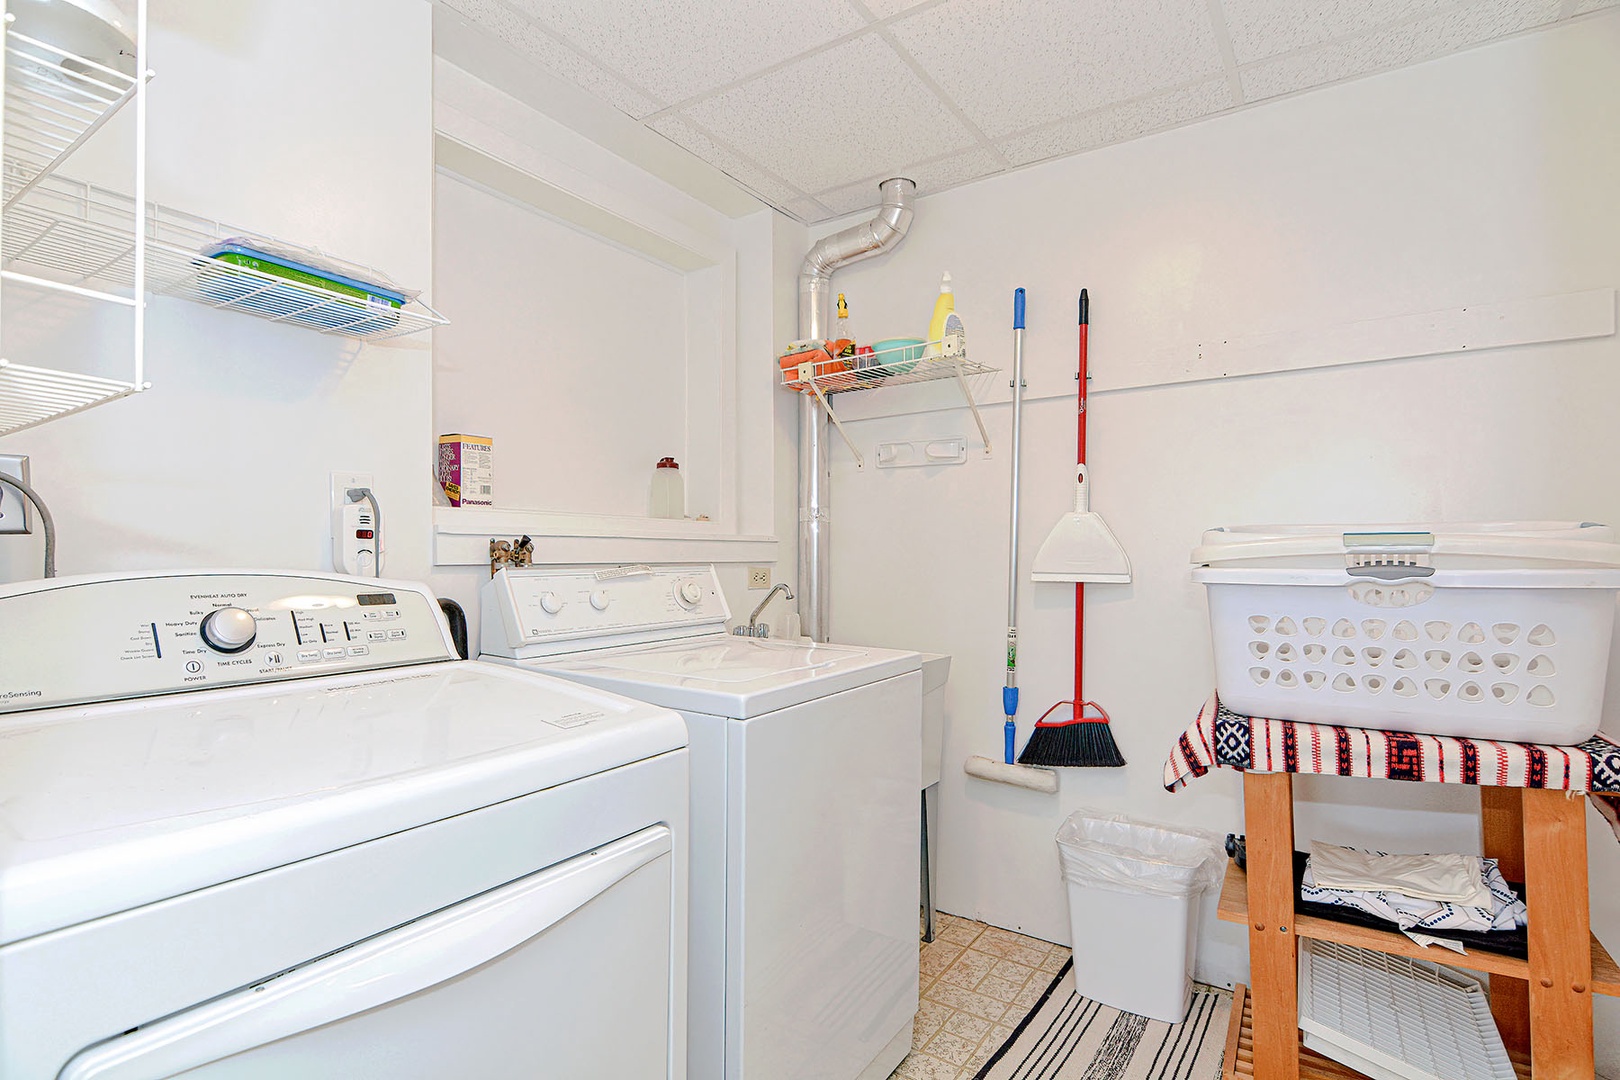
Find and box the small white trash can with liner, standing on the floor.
[1058,810,1221,1023]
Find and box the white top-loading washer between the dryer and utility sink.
[481,567,922,1080]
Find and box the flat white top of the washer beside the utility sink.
[525,633,922,719]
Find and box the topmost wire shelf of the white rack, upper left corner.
[0,29,139,204]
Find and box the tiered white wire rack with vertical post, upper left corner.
[0,0,151,436]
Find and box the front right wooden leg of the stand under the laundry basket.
[1523,789,1594,1080]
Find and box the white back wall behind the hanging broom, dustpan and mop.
[818,15,1620,1072]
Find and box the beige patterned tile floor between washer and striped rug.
[891,912,1069,1080]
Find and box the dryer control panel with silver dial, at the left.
[0,572,455,712]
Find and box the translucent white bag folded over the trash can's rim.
[1058,810,1225,897]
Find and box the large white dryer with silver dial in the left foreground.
[0,572,687,1080]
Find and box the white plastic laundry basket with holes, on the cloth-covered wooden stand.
[1192,521,1620,745]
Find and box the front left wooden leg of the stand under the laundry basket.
[1243,772,1302,1080]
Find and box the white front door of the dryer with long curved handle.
[60,826,677,1080]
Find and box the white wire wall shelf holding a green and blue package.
[0,176,447,340]
